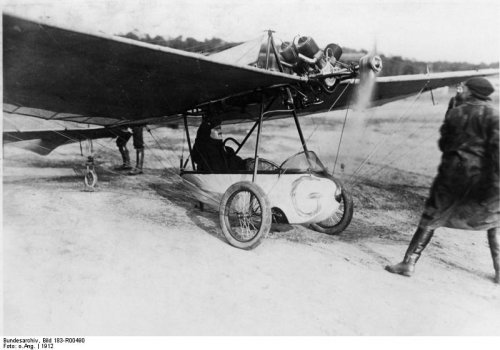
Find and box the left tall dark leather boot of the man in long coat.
[385,227,434,277]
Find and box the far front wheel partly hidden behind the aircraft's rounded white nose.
[311,179,354,235]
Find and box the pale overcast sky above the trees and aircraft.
[4,0,500,63]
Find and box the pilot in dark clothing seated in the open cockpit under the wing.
[191,118,246,173]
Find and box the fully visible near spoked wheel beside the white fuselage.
[219,181,272,249]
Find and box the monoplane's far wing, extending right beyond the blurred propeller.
[301,69,498,114]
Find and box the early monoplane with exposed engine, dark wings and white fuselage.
[3,13,498,249]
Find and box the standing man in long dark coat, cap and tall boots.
[386,78,500,283]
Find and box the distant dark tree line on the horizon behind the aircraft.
[120,32,499,76]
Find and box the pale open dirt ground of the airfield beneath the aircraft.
[2,80,500,336]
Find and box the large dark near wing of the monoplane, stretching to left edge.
[3,14,302,125]
